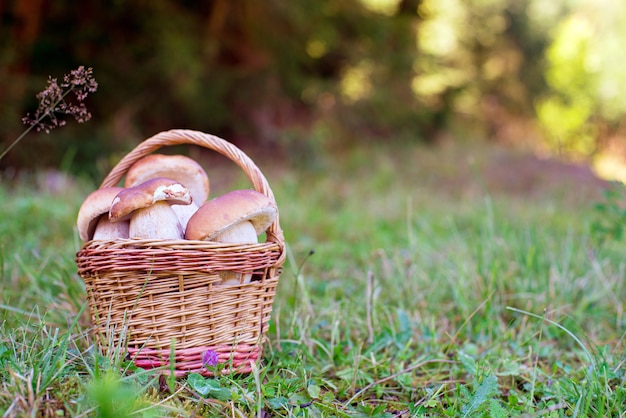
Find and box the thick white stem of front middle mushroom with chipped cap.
[129,201,184,239]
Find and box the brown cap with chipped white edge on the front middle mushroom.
[109,177,192,222]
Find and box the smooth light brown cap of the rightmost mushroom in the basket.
[185,190,278,241]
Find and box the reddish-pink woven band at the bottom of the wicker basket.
[128,344,261,377]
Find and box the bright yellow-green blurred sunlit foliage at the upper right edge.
[536,0,626,157]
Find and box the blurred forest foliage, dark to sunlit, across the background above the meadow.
[0,0,626,178]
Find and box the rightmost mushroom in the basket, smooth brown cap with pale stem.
[185,190,278,284]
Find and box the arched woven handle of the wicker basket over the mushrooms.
[100,129,285,248]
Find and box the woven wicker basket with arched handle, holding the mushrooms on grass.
[76,130,285,376]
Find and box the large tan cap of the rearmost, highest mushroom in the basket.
[124,154,209,206]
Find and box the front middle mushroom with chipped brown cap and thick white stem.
[109,177,192,239]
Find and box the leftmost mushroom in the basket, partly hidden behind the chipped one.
[76,187,129,242]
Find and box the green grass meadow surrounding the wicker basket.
[0,142,626,417]
